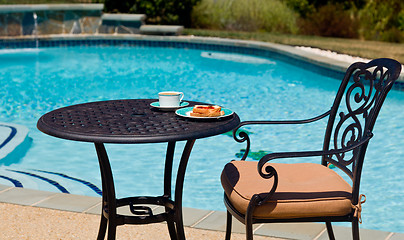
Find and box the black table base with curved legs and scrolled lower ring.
[95,140,195,240]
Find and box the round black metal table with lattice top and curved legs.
[37,99,240,239]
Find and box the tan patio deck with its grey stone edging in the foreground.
[0,185,404,240]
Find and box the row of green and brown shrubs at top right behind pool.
[192,0,404,42]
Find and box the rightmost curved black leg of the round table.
[175,140,195,240]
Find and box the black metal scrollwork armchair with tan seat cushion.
[221,58,401,240]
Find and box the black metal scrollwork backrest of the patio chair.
[322,59,401,202]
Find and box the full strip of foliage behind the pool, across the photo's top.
[0,0,404,43]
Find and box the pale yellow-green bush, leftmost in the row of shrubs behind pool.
[192,0,297,33]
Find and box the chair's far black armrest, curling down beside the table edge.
[233,110,331,160]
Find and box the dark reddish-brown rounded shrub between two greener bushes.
[300,4,359,38]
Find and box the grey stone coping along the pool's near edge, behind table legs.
[0,184,404,240]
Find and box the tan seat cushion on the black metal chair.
[221,161,352,219]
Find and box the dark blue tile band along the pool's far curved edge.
[0,35,404,90]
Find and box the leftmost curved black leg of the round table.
[94,143,117,240]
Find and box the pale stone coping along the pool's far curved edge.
[0,34,404,83]
